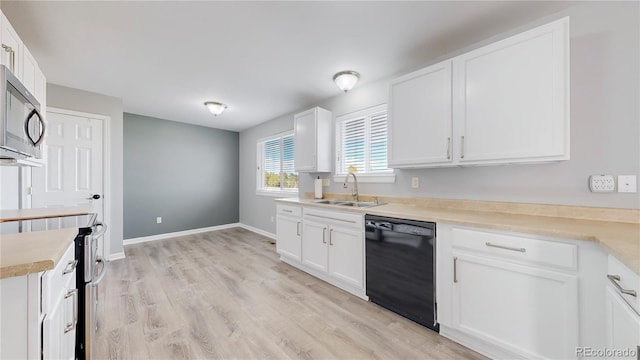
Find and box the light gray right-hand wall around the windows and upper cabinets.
[240,2,640,233]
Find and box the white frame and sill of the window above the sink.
[333,104,396,183]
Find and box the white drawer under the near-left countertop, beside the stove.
[42,243,77,313]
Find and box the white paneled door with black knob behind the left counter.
[32,110,104,226]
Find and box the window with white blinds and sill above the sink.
[334,104,395,182]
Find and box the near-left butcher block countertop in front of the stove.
[0,228,78,279]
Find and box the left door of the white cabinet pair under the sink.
[302,220,329,272]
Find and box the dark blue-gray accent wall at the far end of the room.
[124,113,239,239]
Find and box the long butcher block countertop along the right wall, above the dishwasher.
[277,194,640,274]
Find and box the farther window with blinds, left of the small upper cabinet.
[257,132,298,195]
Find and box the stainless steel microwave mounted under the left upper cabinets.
[0,65,45,160]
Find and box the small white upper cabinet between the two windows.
[293,107,331,172]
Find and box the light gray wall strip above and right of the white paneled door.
[47,84,124,255]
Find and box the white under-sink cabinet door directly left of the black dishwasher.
[329,226,364,289]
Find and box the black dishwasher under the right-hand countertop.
[365,215,440,331]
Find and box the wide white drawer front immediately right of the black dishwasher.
[453,228,578,270]
